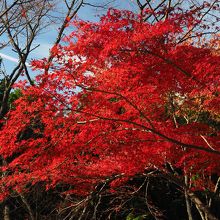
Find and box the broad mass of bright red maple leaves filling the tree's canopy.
[0,10,220,199]
